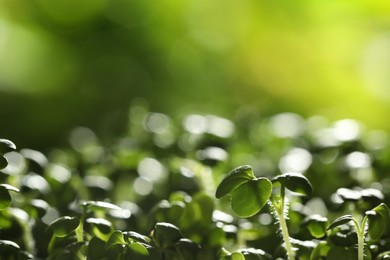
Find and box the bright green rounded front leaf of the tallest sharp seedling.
[231,178,272,217]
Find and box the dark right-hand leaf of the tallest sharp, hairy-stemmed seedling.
[272,173,313,196]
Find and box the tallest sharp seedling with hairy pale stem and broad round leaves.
[216,165,312,260]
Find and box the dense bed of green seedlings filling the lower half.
[0,109,390,260]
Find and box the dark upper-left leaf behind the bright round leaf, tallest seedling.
[215,165,256,199]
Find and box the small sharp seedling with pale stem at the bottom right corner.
[327,203,390,260]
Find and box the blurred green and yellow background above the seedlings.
[0,0,390,149]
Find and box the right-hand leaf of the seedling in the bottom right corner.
[366,203,389,240]
